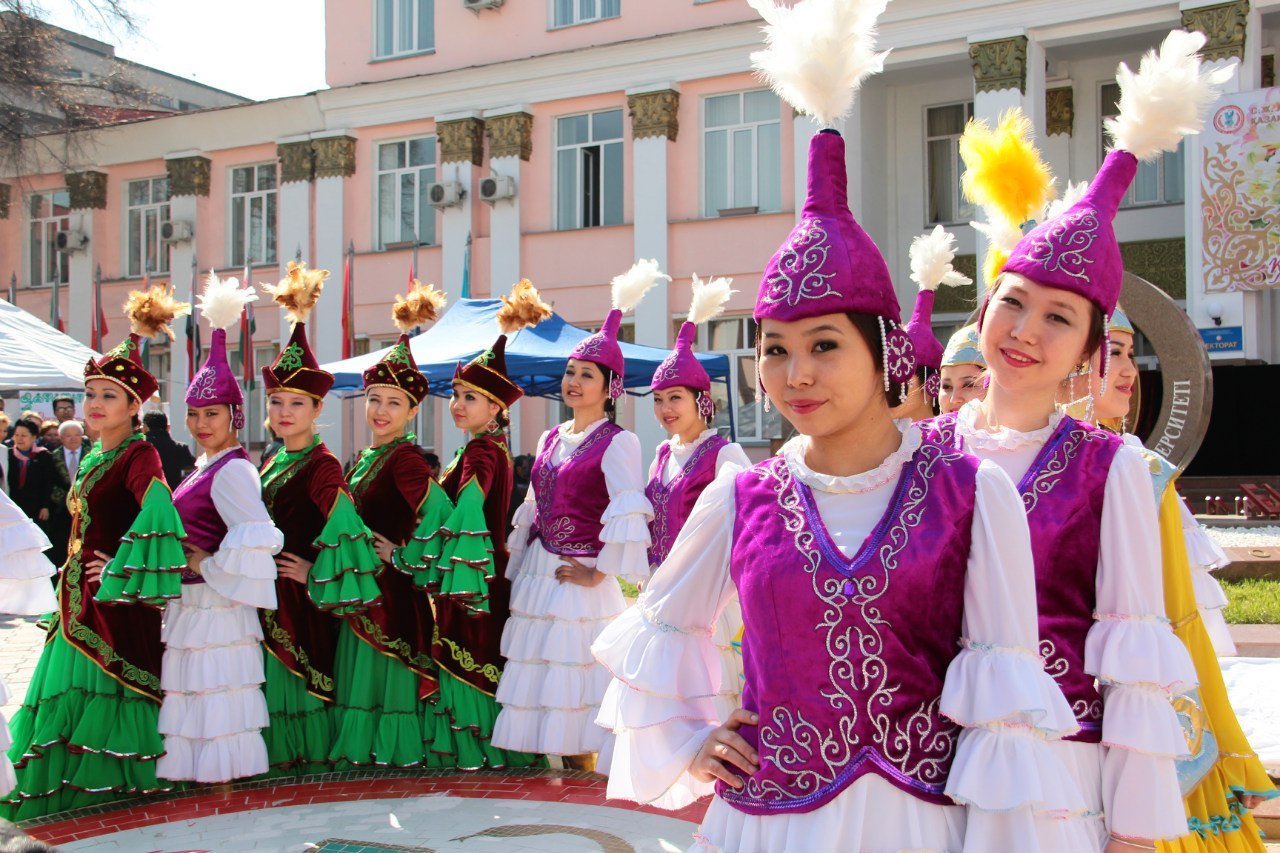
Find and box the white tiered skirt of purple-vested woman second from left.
[156,583,269,783]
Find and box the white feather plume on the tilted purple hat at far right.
[1106,29,1235,160]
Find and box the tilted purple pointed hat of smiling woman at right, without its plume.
[1004,150,1138,316]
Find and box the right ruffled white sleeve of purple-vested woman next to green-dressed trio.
[595,432,653,584]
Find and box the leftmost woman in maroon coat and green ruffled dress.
[0,284,189,820]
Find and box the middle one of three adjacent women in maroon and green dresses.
[329,282,452,770]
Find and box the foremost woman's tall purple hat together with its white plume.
[749,0,915,391]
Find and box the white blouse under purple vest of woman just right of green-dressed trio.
[507,418,653,583]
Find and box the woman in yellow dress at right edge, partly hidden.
[1073,307,1276,853]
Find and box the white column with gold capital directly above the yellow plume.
[969,29,1046,293]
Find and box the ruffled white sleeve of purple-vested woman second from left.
[200,459,284,610]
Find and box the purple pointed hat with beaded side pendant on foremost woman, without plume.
[755,128,914,382]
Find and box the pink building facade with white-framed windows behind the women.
[0,0,1280,466]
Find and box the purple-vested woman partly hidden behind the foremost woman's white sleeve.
[645,275,751,722]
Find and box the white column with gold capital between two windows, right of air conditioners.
[627,83,692,470]
